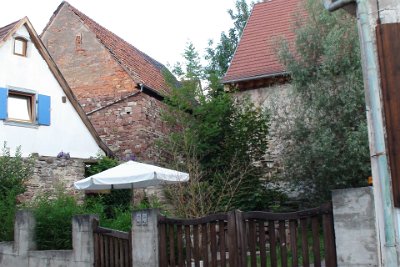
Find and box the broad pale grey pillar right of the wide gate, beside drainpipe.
[332,187,379,267]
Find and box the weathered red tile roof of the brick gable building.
[48,1,170,95]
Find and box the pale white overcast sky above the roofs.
[0,0,250,69]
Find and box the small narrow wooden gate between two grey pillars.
[93,221,132,267]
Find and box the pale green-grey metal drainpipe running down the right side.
[324,0,398,267]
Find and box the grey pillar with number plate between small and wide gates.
[132,209,159,267]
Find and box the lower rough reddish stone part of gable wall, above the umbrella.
[89,93,166,162]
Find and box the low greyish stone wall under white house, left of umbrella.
[18,157,88,202]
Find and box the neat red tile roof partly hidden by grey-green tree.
[223,0,303,83]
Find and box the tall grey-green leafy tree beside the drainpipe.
[280,0,370,205]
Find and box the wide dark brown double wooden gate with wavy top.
[159,204,337,267]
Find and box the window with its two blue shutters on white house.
[0,88,51,125]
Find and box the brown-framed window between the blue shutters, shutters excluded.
[7,91,35,123]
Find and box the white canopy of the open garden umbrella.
[74,161,189,190]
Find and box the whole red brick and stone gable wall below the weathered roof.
[42,6,168,162]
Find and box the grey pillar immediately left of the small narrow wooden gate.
[72,215,98,266]
